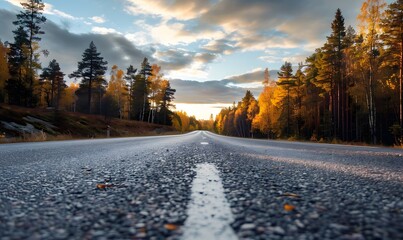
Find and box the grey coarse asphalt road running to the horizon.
[0,131,403,239]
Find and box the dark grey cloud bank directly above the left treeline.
[0,9,155,79]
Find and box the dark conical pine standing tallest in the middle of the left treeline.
[69,42,108,113]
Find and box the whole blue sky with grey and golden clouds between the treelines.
[0,0,390,119]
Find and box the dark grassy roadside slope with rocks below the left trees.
[0,104,175,143]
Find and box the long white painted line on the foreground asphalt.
[182,163,238,240]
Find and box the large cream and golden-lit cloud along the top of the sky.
[126,0,361,54]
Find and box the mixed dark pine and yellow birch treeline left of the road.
[0,0,180,125]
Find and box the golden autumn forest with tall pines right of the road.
[214,0,403,146]
